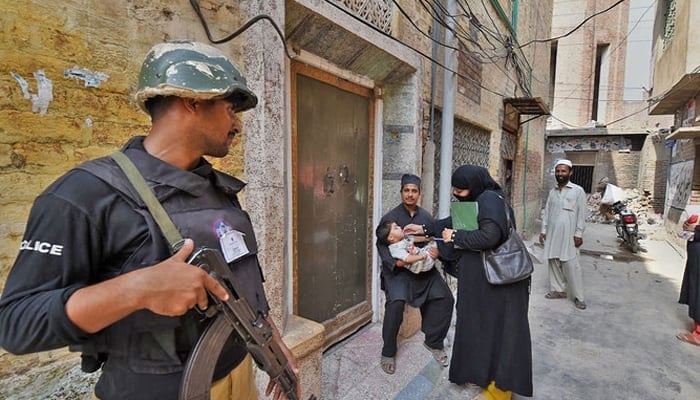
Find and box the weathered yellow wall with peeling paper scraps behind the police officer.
[0,0,260,398]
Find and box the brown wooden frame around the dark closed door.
[290,61,378,350]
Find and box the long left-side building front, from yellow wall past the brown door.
[0,0,552,397]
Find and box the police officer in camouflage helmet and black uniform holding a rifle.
[0,41,296,400]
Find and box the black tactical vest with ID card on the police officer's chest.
[71,142,269,379]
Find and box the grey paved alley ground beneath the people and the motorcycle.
[323,224,700,400]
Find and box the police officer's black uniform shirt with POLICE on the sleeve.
[0,138,269,399]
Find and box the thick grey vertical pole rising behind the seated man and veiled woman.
[438,0,457,218]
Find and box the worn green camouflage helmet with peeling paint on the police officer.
[136,41,258,112]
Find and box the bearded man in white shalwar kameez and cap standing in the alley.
[540,159,586,310]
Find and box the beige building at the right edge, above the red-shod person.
[650,0,700,237]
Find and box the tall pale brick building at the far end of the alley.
[543,0,669,206]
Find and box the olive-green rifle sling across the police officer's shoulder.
[111,151,184,254]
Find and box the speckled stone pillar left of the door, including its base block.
[238,0,324,398]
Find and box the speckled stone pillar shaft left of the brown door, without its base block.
[241,1,288,324]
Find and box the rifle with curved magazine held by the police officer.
[179,247,316,400]
